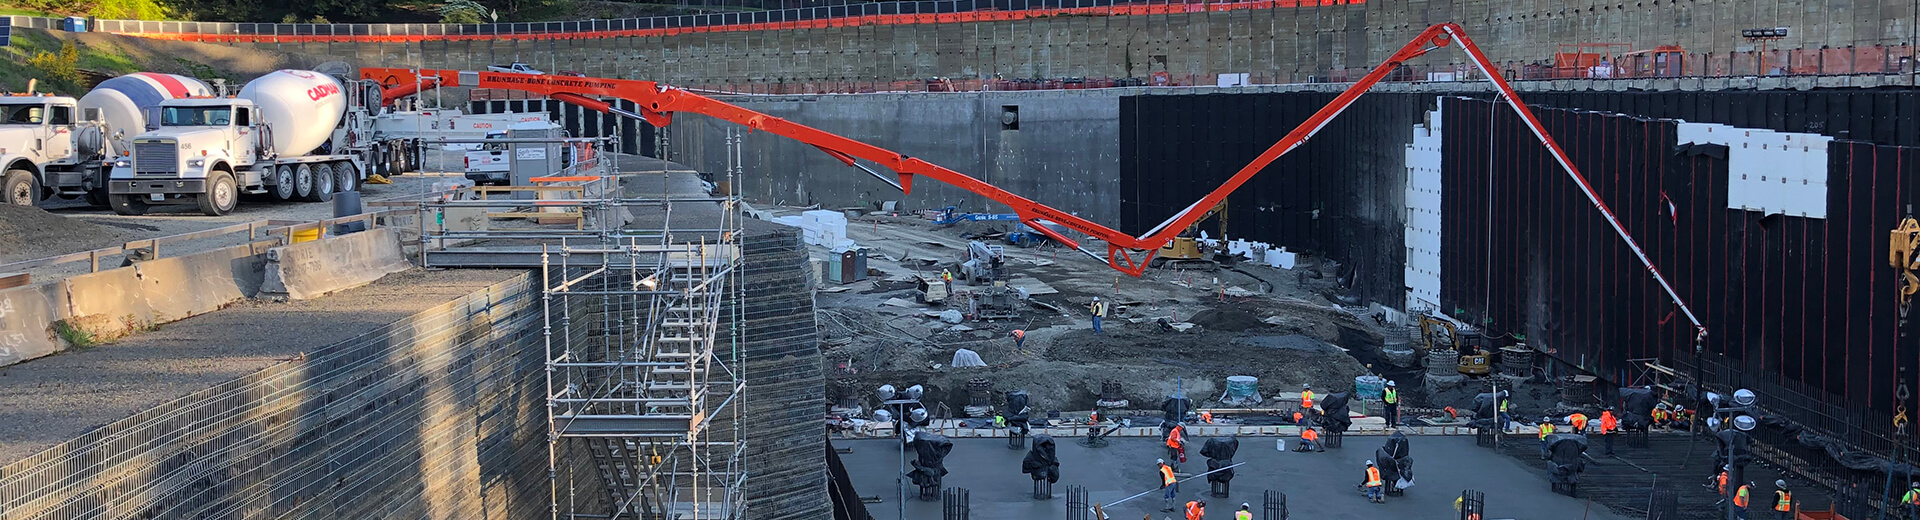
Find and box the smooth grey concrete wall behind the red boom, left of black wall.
[666,90,1121,223]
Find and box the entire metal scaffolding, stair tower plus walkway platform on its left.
[401,129,747,520]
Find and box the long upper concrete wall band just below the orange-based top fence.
[210,0,1920,84]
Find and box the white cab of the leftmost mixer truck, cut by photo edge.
[0,96,106,205]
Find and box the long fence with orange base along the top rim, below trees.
[13,0,1365,42]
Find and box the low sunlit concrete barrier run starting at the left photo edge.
[0,242,273,366]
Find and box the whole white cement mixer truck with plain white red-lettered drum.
[108,71,413,215]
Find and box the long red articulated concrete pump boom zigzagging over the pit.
[361,23,1707,338]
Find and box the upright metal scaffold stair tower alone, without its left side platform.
[540,131,747,520]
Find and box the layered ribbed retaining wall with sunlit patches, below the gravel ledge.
[0,276,595,520]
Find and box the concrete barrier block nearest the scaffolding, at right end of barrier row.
[261,228,413,299]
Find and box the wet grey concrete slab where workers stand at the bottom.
[835,436,1626,520]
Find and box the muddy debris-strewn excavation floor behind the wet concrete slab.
[802,211,1405,420]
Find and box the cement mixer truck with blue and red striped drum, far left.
[0,73,213,205]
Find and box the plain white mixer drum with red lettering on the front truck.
[240,69,348,157]
